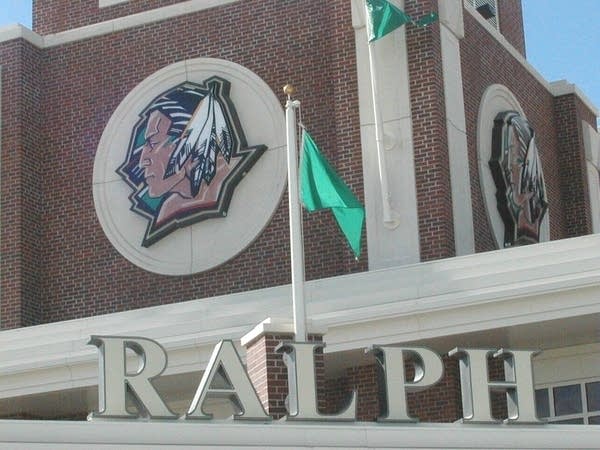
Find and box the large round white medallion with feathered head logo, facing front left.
[93,58,286,275]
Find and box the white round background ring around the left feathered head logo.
[93,58,287,275]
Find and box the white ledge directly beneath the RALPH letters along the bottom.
[0,420,600,450]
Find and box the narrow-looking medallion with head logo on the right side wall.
[477,84,550,248]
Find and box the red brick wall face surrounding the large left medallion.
[2,0,366,328]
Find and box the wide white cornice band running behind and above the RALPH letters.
[0,235,600,398]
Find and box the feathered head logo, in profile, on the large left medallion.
[117,77,266,247]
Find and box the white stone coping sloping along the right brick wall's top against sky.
[463,0,600,116]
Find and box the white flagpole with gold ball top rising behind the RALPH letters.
[283,85,307,342]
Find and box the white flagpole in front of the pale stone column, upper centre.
[365,2,400,228]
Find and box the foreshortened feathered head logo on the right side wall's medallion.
[489,111,548,247]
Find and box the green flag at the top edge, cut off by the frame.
[366,0,437,42]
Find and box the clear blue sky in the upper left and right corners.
[0,0,600,114]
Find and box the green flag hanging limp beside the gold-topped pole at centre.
[300,131,365,258]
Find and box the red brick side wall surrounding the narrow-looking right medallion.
[460,12,590,252]
